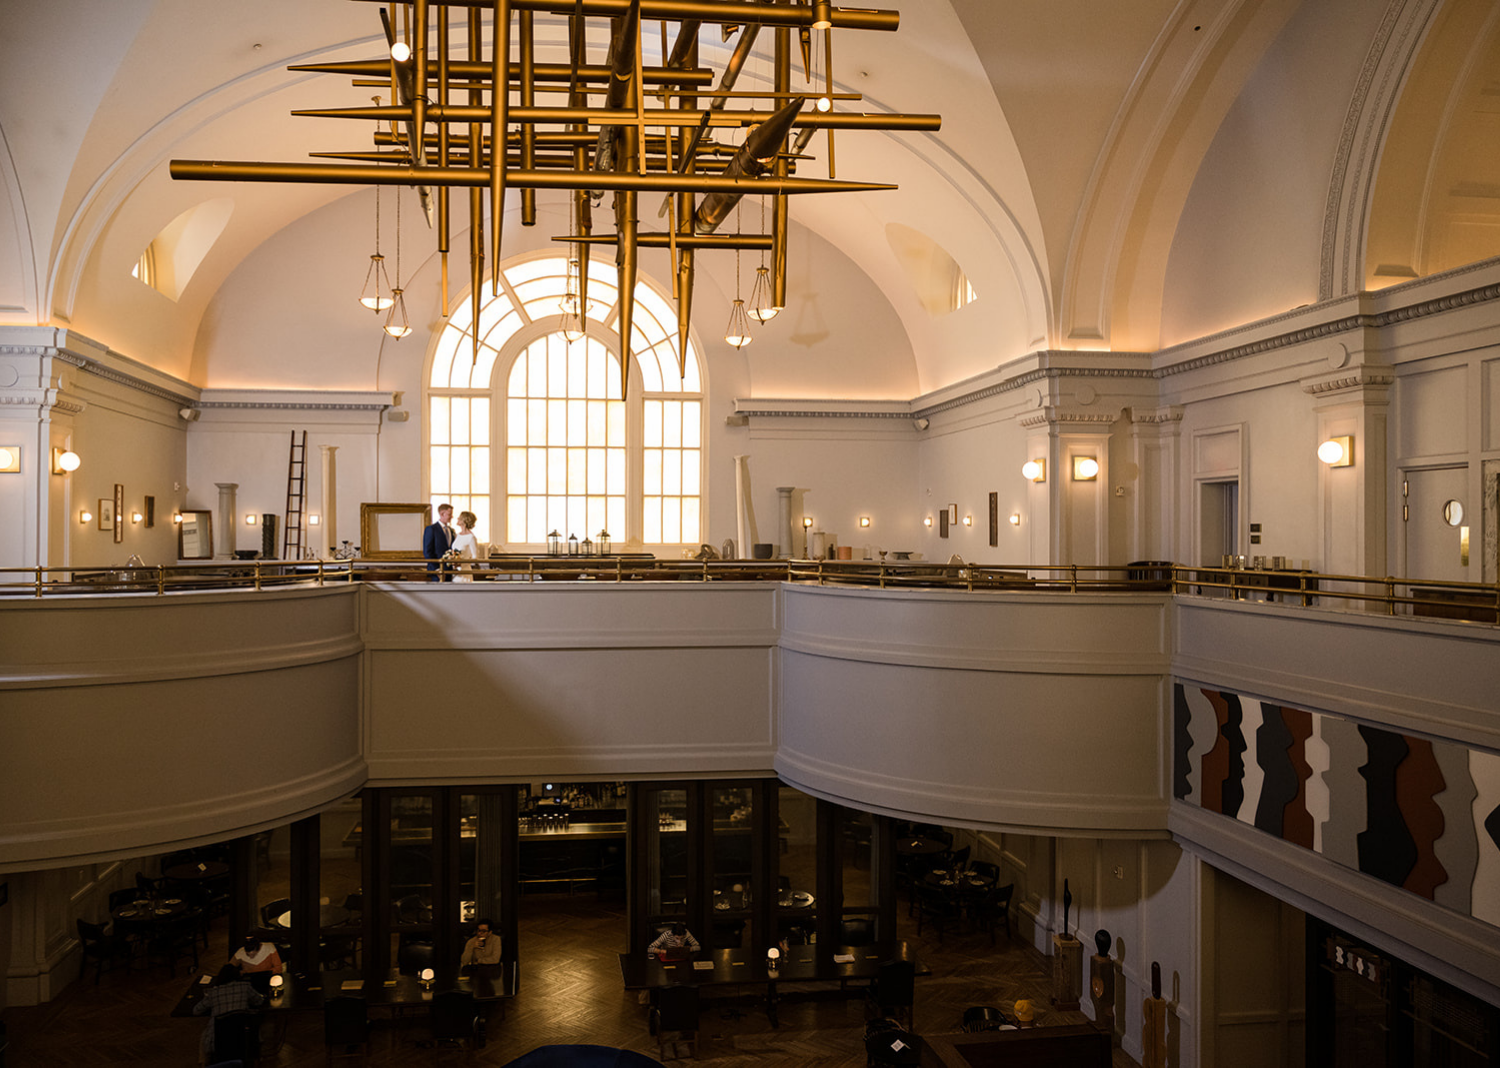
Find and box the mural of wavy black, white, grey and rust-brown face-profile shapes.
[1172,683,1500,927]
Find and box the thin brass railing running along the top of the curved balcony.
[0,555,1500,624]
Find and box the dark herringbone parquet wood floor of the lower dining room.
[5,896,1134,1068]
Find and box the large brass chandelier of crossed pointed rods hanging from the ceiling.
[171,0,942,396]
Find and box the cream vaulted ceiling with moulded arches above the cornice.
[0,0,1500,390]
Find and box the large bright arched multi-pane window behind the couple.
[426,252,704,551]
